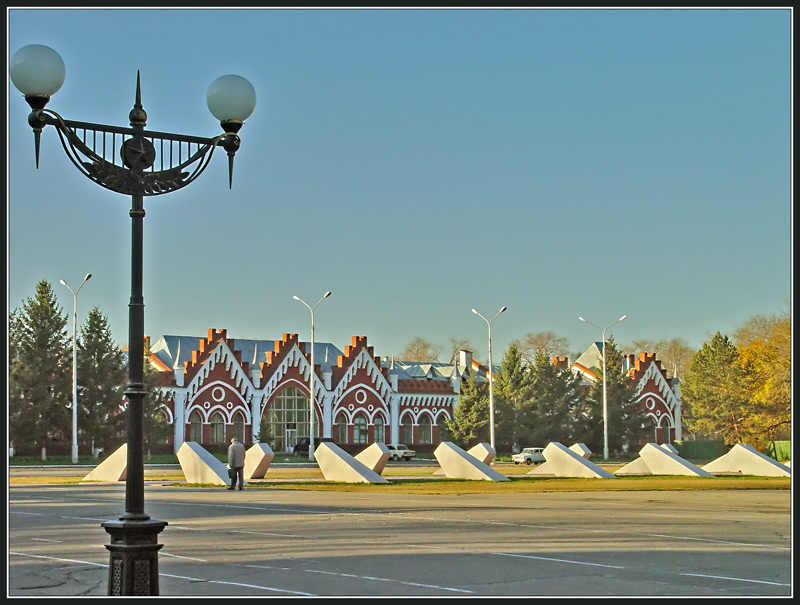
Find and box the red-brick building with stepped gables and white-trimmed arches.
[144,329,681,453]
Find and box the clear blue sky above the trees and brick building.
[7,9,792,358]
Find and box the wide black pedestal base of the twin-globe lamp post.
[101,519,167,596]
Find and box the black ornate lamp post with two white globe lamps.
[9,44,256,595]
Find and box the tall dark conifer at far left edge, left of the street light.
[8,280,72,453]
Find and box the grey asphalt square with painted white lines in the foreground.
[8,484,792,597]
